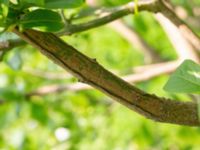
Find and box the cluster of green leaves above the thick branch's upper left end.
[0,0,84,32]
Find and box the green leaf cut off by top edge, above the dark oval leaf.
[44,0,84,9]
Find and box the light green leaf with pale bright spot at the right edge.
[164,60,200,93]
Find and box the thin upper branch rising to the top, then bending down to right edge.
[55,0,200,54]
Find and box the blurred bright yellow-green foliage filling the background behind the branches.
[0,0,200,150]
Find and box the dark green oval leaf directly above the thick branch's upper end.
[20,9,64,32]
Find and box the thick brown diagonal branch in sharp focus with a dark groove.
[14,29,200,126]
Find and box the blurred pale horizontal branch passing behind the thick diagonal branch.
[26,61,181,97]
